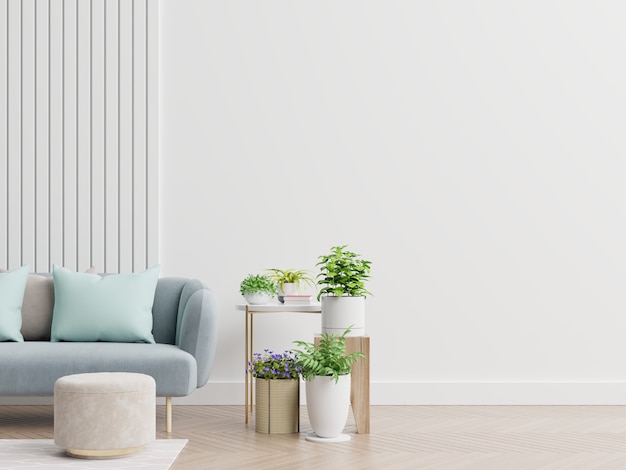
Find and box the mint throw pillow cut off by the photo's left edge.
[0,265,30,342]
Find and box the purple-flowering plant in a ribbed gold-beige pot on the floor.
[246,349,300,434]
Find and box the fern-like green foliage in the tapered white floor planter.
[294,328,365,383]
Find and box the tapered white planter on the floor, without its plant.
[306,374,350,442]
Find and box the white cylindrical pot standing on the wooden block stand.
[322,296,365,336]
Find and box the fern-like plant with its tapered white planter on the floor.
[294,328,365,442]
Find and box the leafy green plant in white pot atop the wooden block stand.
[316,245,372,336]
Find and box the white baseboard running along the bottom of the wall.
[0,382,626,405]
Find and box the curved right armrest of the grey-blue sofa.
[176,280,218,387]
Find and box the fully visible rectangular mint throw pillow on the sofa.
[50,265,160,343]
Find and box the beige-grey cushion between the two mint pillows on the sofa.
[0,267,96,341]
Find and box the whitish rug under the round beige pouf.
[0,439,187,470]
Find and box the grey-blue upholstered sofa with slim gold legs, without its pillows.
[0,277,218,432]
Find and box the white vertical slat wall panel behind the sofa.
[0,0,158,272]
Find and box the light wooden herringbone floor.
[0,406,626,470]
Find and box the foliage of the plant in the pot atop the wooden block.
[316,245,372,300]
